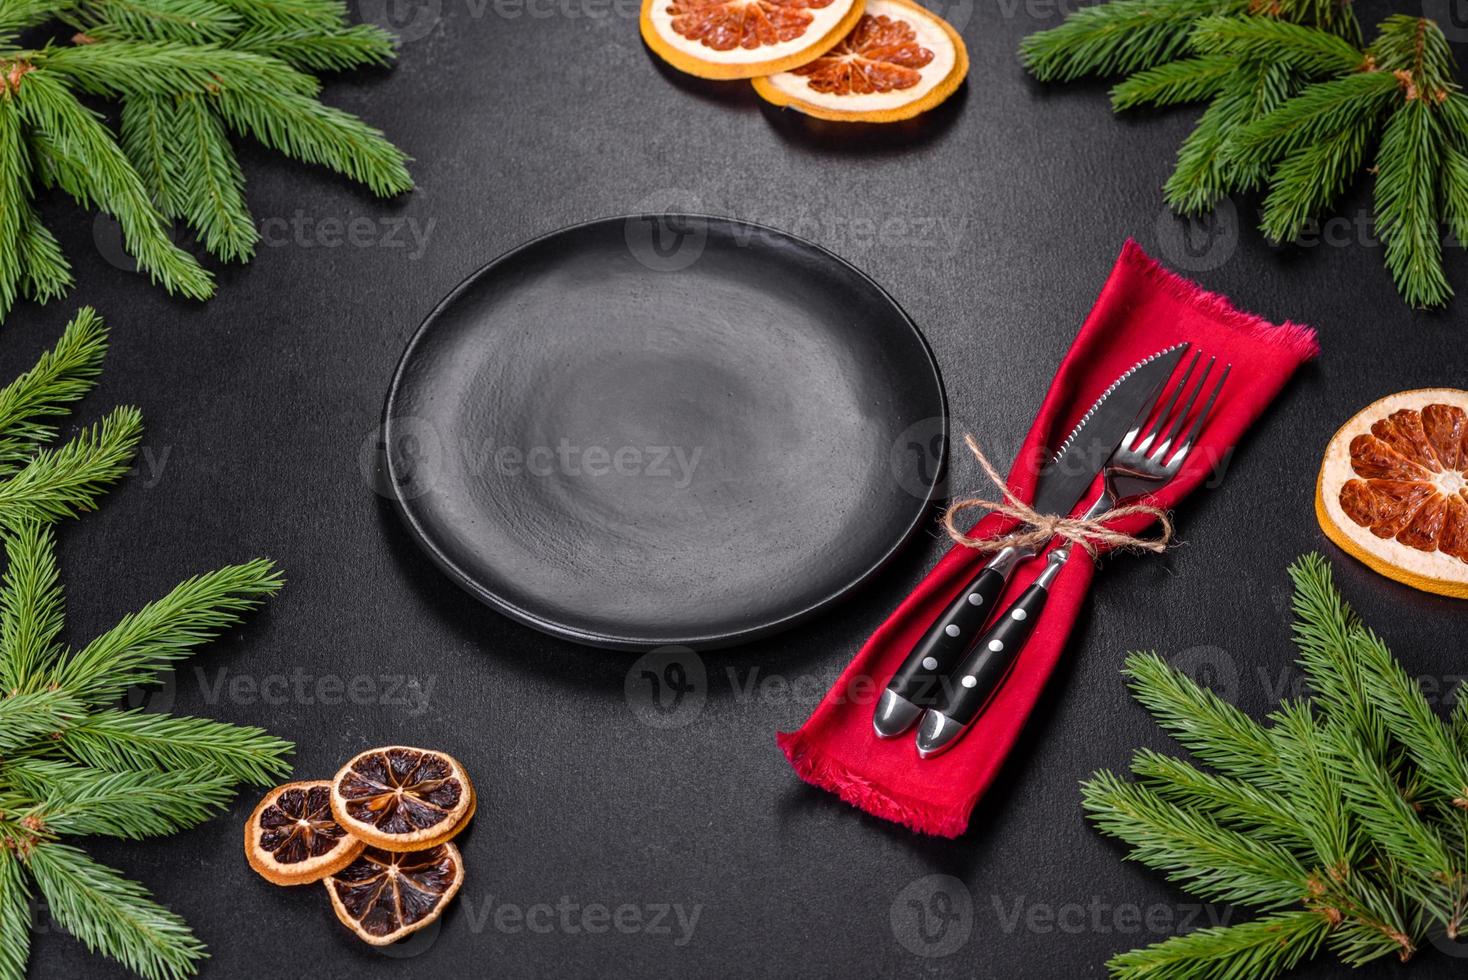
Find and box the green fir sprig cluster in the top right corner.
[1020,0,1468,307]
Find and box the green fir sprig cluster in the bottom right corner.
[1082,555,1468,980]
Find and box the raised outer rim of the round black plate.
[379,211,951,653]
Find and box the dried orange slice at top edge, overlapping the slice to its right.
[642,0,862,79]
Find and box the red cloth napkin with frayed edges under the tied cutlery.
[778,241,1320,838]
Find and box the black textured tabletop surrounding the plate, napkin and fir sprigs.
[17,0,1468,979]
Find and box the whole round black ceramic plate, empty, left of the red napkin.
[383,216,947,648]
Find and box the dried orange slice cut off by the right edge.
[1315,387,1468,599]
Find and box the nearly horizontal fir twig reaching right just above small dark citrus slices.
[57,710,295,786]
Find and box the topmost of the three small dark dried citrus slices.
[332,745,474,851]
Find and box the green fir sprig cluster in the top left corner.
[0,0,413,320]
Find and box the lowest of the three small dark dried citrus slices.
[326,844,464,946]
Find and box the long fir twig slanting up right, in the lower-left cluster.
[50,559,283,704]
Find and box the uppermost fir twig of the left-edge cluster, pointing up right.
[0,307,107,475]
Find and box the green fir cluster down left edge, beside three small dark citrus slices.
[0,309,292,980]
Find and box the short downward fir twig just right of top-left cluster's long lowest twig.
[172,95,260,261]
